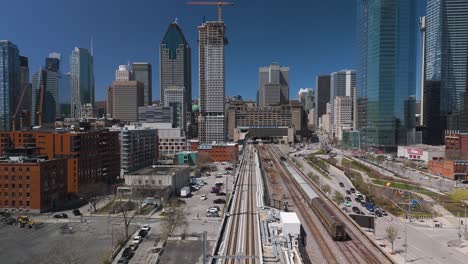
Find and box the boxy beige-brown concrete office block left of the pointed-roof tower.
[111,81,144,123]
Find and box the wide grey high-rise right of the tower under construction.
[258,62,289,107]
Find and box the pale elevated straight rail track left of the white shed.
[224,145,259,264]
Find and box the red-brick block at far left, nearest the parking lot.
[0,157,67,212]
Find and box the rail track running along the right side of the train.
[266,147,393,264]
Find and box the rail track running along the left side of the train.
[267,145,339,263]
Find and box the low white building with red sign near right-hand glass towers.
[398,144,445,163]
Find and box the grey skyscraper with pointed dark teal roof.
[160,23,193,133]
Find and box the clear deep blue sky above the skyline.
[0,0,376,100]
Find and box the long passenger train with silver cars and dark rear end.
[281,156,348,241]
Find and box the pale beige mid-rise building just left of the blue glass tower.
[333,96,353,140]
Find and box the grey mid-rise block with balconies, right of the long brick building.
[111,125,159,175]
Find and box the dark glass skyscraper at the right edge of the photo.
[422,0,468,145]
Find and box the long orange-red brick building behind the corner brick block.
[0,130,120,196]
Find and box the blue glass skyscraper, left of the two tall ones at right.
[357,0,418,150]
